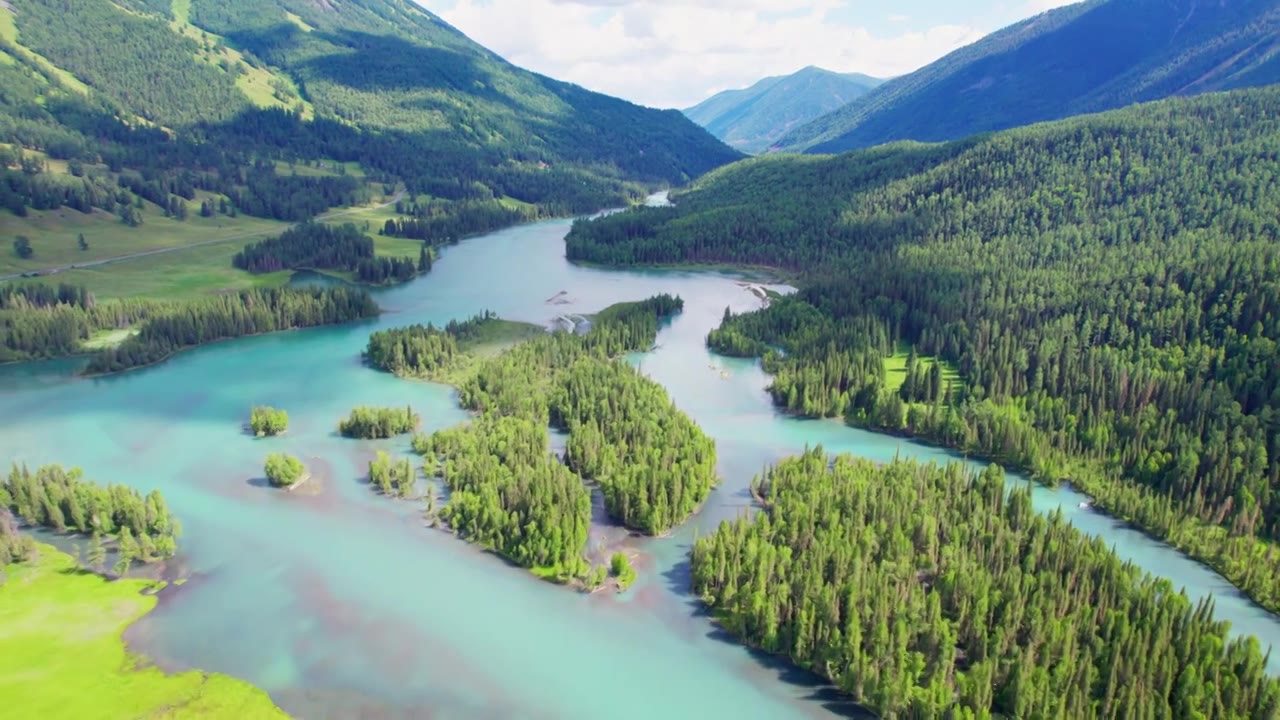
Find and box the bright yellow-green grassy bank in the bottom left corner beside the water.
[0,544,287,720]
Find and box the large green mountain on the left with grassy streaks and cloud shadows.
[0,0,740,224]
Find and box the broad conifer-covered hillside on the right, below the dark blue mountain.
[568,83,1280,610]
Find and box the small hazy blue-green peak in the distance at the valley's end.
[684,65,884,152]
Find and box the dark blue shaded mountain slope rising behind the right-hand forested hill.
[777,0,1280,152]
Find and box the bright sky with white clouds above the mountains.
[417,0,1071,108]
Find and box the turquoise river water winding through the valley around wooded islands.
[0,210,1280,719]
